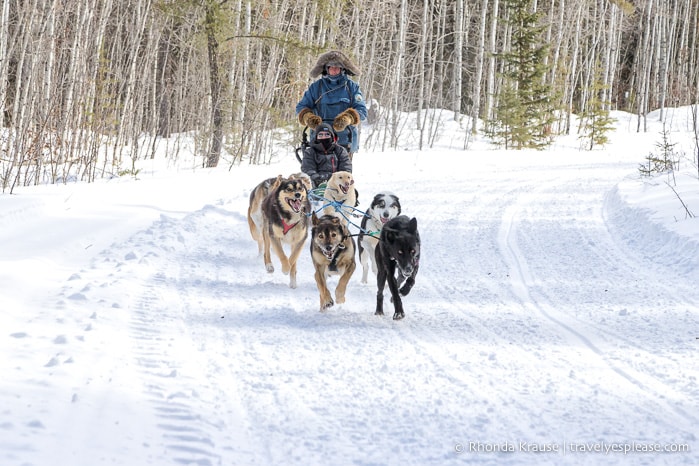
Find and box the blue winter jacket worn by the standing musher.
[296,73,367,153]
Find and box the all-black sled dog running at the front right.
[375,215,420,320]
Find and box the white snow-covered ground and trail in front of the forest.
[0,109,699,466]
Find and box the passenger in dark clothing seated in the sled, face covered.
[301,123,352,191]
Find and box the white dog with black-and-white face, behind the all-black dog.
[357,191,401,283]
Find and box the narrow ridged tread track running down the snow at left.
[114,231,220,466]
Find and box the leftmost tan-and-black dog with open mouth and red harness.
[248,176,310,288]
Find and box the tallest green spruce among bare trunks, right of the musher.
[486,0,554,149]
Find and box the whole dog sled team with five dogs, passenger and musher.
[248,51,420,320]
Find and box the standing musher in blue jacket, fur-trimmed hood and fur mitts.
[296,50,367,160]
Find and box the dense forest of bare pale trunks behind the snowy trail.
[0,0,699,192]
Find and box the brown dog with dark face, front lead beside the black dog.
[311,213,357,311]
